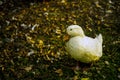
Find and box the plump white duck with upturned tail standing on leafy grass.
[66,25,103,63]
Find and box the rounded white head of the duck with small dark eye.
[67,25,85,37]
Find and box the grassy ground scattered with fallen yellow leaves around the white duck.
[0,0,120,80]
